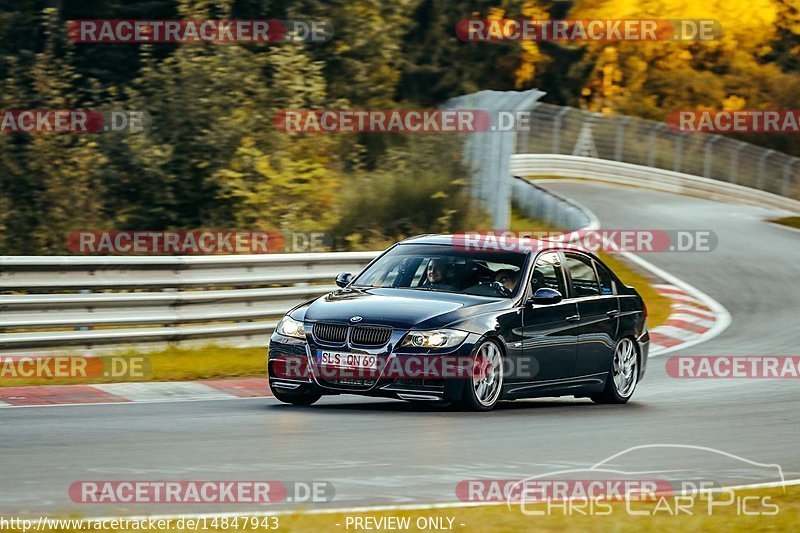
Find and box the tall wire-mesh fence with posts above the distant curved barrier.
[514,103,800,204]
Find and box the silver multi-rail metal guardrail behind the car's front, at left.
[0,252,378,354]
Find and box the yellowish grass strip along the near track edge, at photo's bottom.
[2,485,800,533]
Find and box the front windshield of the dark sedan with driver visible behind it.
[353,244,527,298]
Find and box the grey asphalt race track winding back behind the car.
[0,182,800,516]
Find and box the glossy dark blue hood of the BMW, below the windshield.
[305,288,508,329]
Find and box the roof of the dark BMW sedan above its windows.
[398,231,596,258]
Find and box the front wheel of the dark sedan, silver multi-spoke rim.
[457,340,503,411]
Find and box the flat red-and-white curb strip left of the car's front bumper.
[0,378,272,409]
